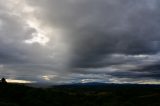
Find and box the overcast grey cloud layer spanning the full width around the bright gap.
[0,0,160,84]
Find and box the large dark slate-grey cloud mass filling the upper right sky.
[27,0,160,68]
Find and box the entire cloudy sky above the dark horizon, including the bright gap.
[0,0,160,84]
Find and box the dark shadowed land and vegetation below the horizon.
[0,84,160,106]
